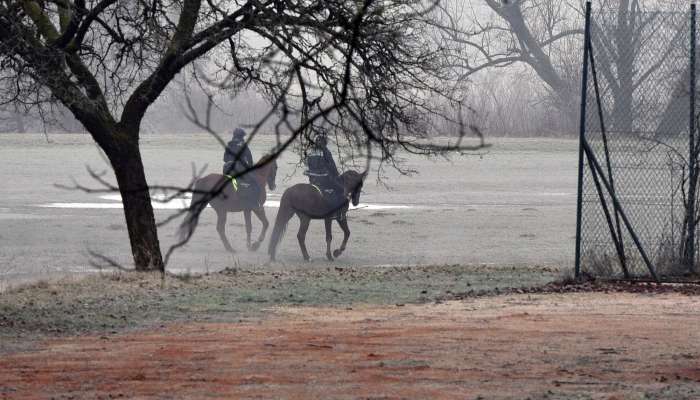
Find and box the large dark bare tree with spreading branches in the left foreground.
[0,0,482,270]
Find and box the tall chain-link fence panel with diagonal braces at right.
[577,5,696,279]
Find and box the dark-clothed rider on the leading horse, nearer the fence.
[306,132,343,203]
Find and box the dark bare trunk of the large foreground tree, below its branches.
[105,139,165,271]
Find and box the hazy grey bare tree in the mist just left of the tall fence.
[446,0,583,126]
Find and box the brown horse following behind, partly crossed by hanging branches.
[180,159,277,253]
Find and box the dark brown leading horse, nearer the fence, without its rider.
[268,171,367,261]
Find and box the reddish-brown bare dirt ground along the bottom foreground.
[0,293,700,399]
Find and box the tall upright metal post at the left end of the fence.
[575,0,591,278]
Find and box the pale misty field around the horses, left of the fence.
[0,135,577,289]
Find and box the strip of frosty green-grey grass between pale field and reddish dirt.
[0,265,560,352]
